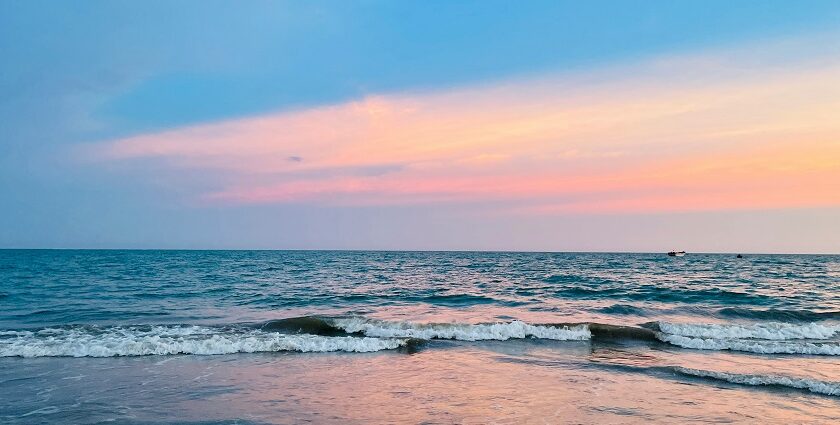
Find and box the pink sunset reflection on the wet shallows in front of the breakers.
[154,342,840,424]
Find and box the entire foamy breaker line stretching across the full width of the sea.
[0,316,840,357]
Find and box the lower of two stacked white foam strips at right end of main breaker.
[656,332,840,356]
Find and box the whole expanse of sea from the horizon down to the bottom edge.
[0,250,840,424]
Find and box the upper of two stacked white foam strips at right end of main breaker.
[659,322,840,340]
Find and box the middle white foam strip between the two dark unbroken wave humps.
[332,317,592,341]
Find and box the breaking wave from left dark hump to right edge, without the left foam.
[236,316,840,355]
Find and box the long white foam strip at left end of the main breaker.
[0,326,406,357]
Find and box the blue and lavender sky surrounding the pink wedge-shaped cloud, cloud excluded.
[0,0,840,252]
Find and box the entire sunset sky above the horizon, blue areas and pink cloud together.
[0,0,840,253]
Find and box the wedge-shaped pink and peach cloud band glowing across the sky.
[90,34,840,214]
